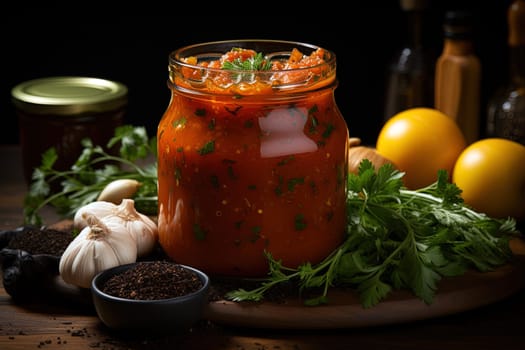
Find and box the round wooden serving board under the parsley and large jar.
[204,240,525,330]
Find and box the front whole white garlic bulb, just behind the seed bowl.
[59,212,137,288]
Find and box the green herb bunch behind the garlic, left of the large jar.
[24,125,158,225]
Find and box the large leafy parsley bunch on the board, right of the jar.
[227,159,519,308]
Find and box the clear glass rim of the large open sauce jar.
[169,39,336,95]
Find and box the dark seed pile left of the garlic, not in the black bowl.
[7,228,74,256]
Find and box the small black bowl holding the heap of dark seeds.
[91,261,210,333]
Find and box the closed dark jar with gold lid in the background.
[11,76,128,183]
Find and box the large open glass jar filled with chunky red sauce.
[157,40,348,277]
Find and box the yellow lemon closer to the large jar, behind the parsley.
[376,107,467,189]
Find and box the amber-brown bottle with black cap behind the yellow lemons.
[434,11,481,144]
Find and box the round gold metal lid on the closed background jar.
[11,76,128,116]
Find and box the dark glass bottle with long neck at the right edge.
[487,0,525,144]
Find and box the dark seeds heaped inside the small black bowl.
[101,260,202,300]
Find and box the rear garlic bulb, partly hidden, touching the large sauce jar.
[109,198,159,257]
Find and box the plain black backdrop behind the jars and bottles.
[0,0,511,144]
